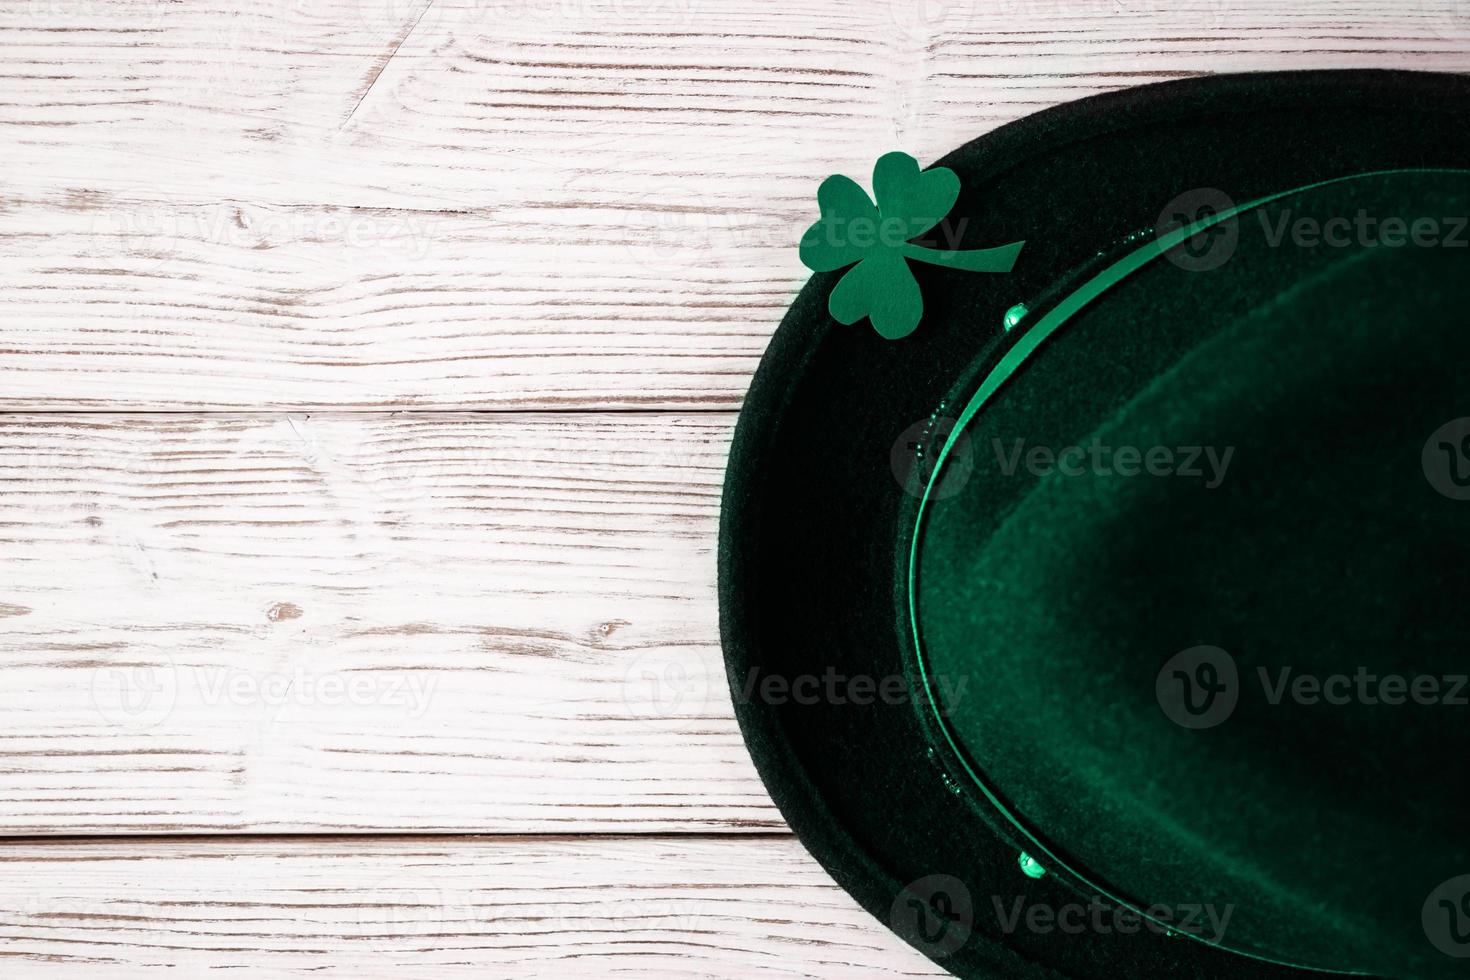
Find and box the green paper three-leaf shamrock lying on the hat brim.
[801,153,1026,341]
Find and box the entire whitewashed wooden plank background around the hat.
[0,0,1470,977]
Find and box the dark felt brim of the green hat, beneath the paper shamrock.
[719,71,1470,980]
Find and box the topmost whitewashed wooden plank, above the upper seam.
[0,0,1470,410]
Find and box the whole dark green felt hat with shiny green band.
[720,71,1470,980]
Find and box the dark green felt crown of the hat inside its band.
[913,173,1470,976]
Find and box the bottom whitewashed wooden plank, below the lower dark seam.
[0,837,945,980]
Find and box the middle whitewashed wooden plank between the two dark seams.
[0,413,784,835]
